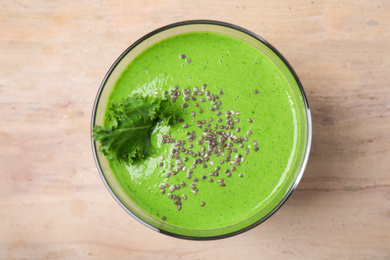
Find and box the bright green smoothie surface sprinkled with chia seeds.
[100,32,301,229]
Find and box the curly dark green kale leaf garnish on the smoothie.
[93,96,175,163]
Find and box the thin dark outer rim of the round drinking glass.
[90,20,312,240]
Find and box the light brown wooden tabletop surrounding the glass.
[0,0,390,260]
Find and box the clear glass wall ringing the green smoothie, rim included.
[91,20,312,240]
